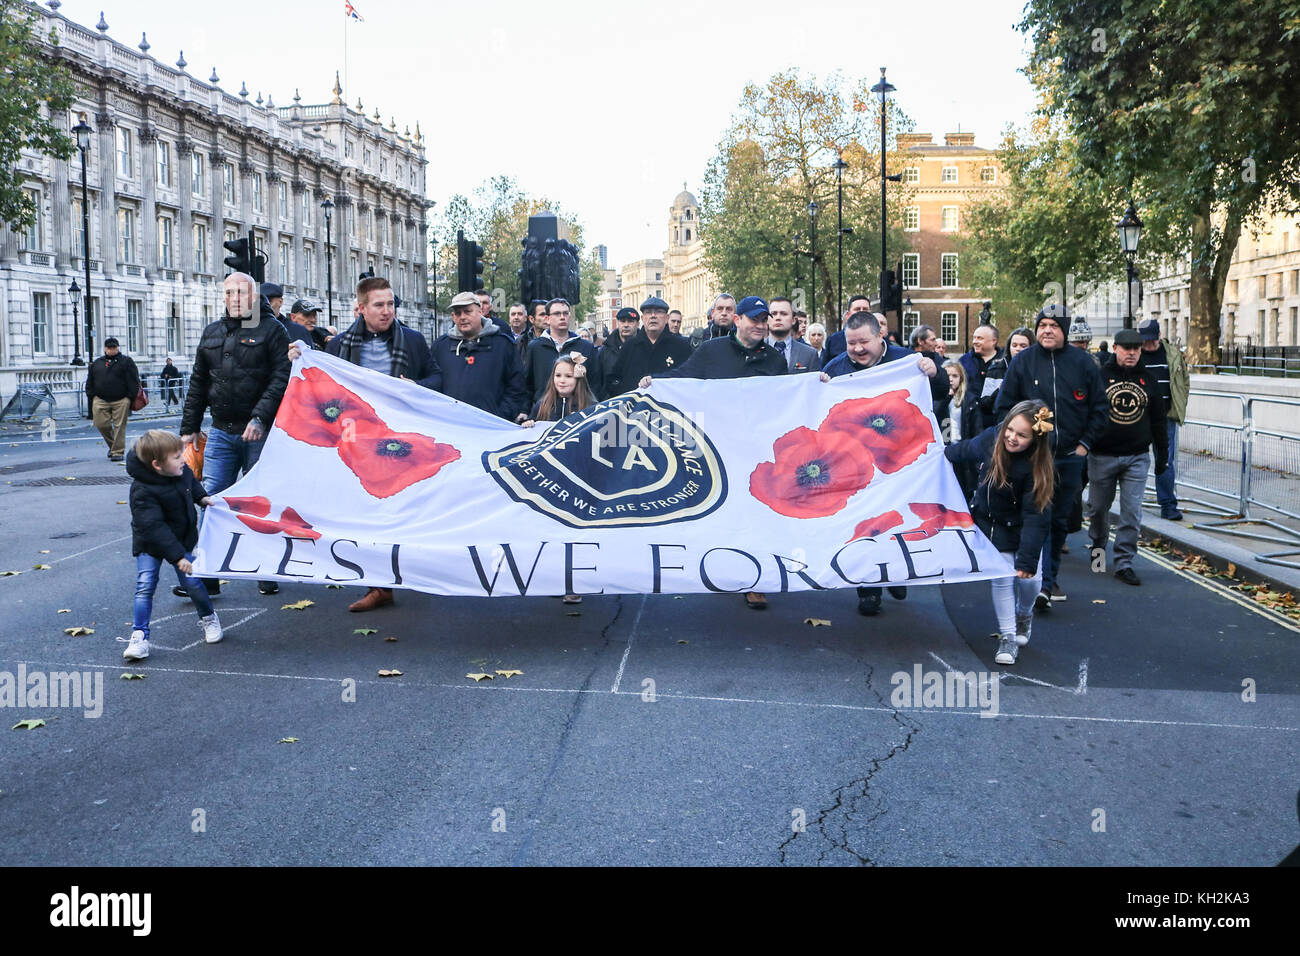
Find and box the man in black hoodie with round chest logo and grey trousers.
[1088,329,1169,587]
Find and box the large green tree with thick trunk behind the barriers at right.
[1019,0,1300,364]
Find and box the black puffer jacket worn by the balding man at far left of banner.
[181,298,293,434]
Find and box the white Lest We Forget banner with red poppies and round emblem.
[196,351,1013,596]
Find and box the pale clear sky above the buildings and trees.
[50,0,1034,268]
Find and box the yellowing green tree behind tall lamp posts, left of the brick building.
[701,70,911,329]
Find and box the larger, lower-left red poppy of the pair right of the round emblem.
[749,428,875,518]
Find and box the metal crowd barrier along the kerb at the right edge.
[1145,389,1300,568]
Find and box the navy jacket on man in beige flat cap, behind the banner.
[432,323,528,421]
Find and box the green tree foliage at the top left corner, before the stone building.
[0,0,75,230]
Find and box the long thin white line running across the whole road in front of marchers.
[7,659,1300,734]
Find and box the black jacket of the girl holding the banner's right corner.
[944,425,1052,574]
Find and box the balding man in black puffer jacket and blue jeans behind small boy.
[172,272,293,597]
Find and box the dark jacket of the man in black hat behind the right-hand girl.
[993,342,1108,460]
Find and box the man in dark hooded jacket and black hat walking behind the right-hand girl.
[995,303,1109,610]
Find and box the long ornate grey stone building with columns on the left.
[0,4,430,397]
